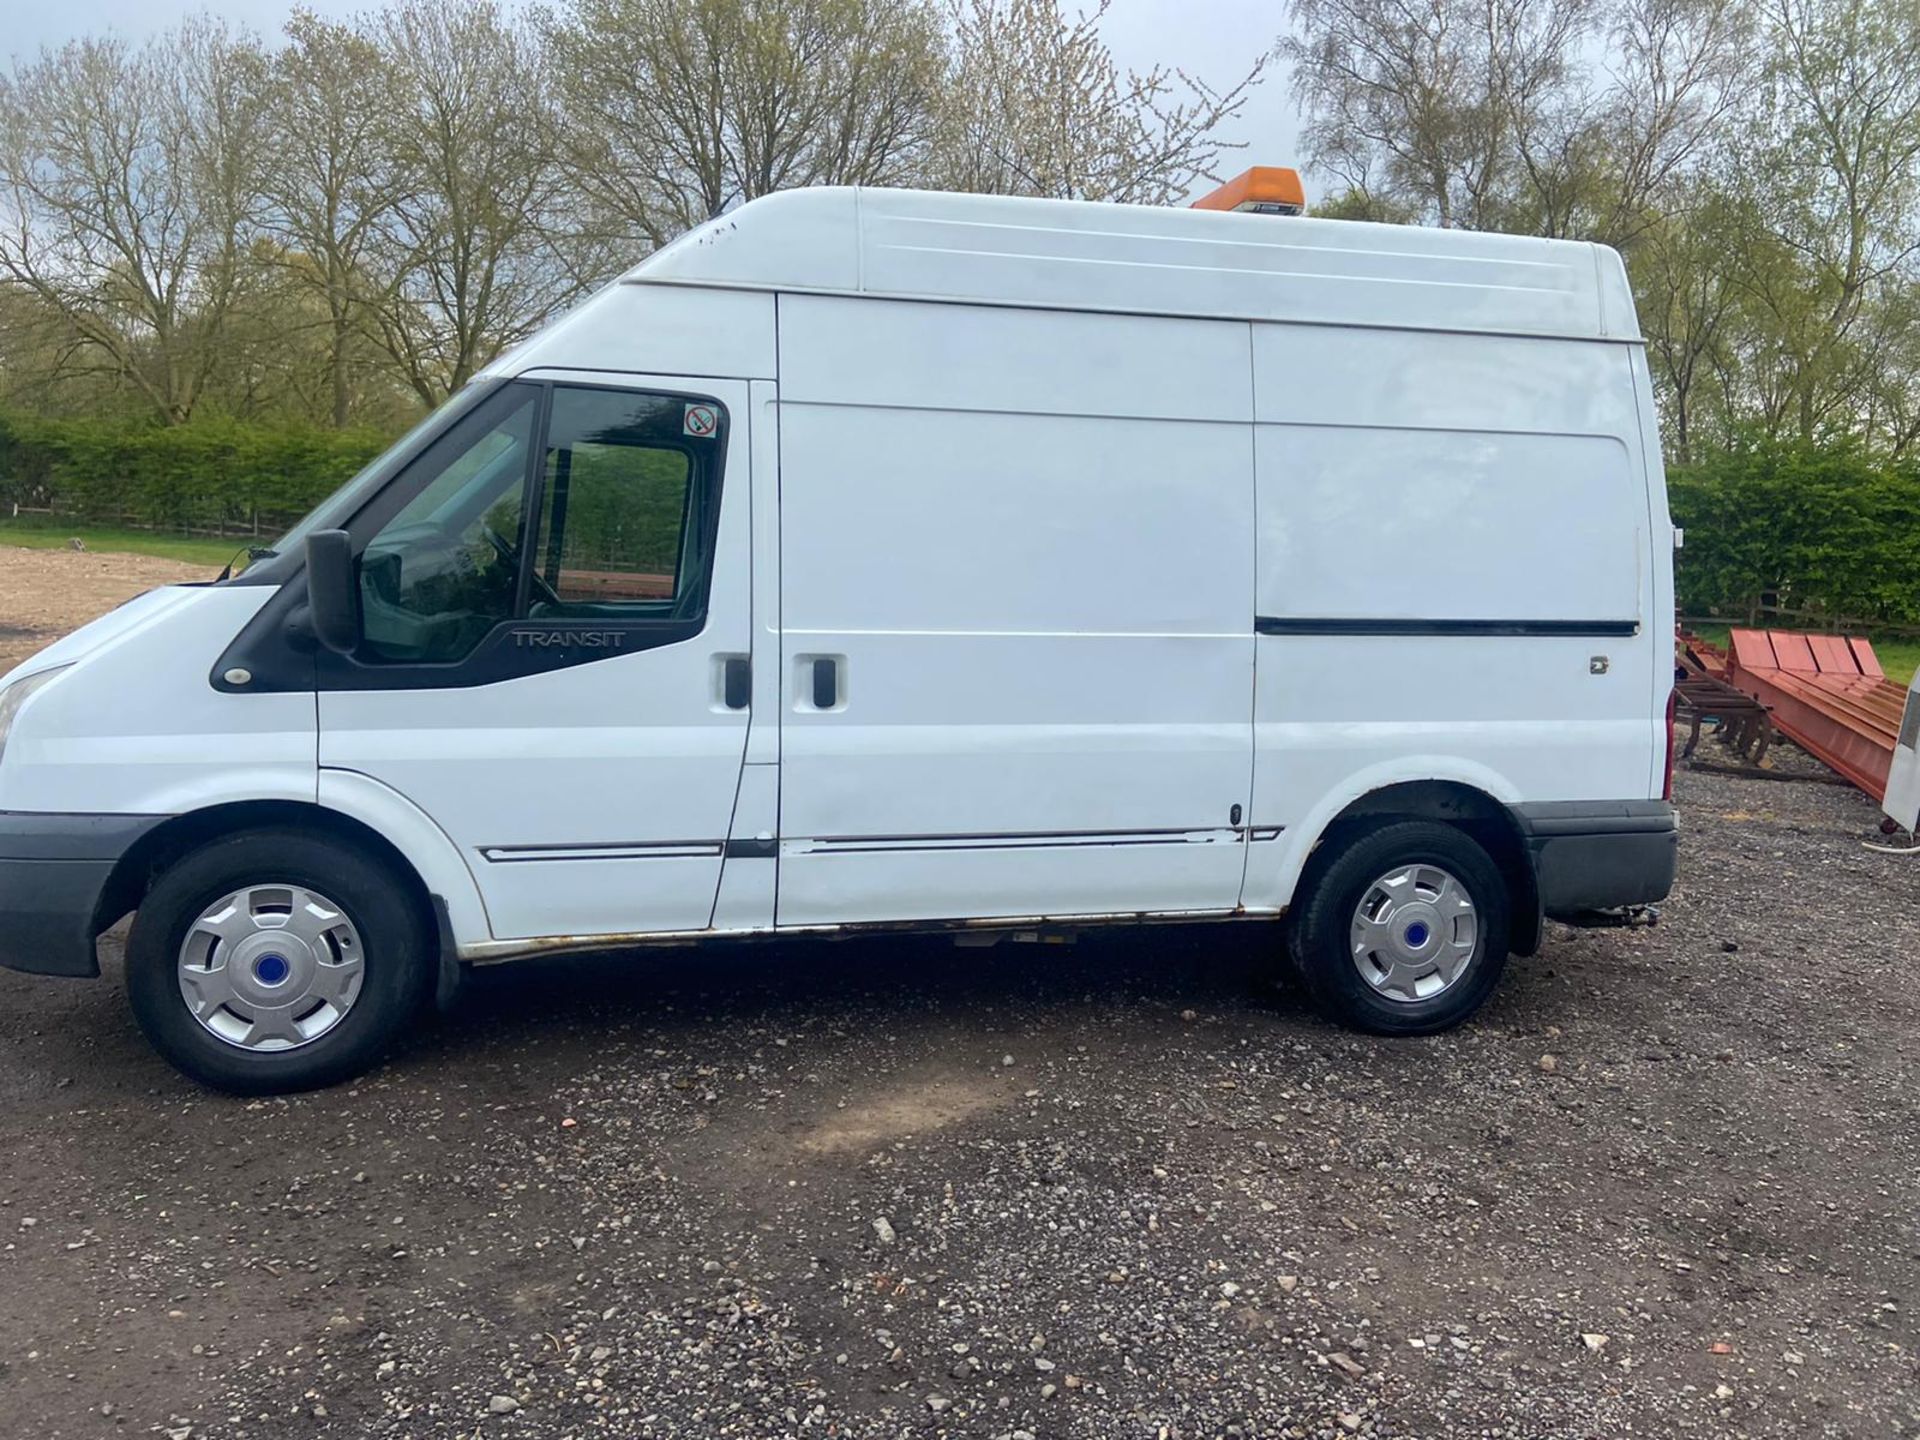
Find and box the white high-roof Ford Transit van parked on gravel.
[0,190,1676,1091]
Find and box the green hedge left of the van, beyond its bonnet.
[0,417,392,534]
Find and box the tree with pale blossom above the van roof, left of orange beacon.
[931,0,1267,205]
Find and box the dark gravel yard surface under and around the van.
[0,556,1920,1440]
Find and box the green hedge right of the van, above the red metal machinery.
[1667,442,1920,624]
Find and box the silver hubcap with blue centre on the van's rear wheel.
[1350,864,1480,1004]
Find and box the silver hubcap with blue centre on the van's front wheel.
[180,885,367,1052]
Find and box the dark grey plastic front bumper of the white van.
[0,810,165,975]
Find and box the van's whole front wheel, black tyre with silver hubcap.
[127,828,434,1094]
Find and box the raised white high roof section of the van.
[622,186,1640,340]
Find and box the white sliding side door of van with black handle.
[780,296,1254,925]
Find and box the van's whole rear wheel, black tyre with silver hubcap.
[1288,820,1509,1035]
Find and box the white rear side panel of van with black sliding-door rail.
[1246,324,1670,906]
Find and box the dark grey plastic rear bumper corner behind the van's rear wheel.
[1513,801,1680,918]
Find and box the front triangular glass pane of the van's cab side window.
[359,386,540,664]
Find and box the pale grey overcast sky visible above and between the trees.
[0,0,1298,200]
